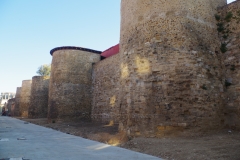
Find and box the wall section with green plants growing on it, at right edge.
[218,1,240,129]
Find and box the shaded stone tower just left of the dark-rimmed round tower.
[28,76,49,118]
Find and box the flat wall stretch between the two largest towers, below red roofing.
[92,54,120,124]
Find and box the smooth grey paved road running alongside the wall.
[0,116,160,160]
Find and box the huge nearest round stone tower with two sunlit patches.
[120,0,226,135]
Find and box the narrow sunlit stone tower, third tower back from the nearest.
[19,80,32,117]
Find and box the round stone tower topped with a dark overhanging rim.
[48,47,101,121]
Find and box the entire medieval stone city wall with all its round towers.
[12,0,240,136]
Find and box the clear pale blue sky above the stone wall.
[0,0,236,92]
